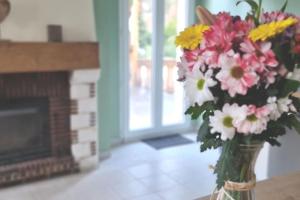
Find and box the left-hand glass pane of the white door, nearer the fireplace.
[129,0,152,130]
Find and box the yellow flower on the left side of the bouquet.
[175,24,209,50]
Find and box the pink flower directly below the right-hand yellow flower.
[240,39,279,73]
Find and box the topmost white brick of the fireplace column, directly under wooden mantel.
[70,69,100,83]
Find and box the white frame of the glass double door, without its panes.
[118,0,195,142]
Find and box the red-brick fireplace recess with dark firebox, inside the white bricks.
[0,72,78,187]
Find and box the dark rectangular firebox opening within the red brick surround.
[0,97,51,165]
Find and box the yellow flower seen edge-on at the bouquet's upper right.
[249,17,298,42]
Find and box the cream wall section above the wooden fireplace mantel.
[1,0,96,41]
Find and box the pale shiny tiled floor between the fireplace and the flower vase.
[0,134,219,200]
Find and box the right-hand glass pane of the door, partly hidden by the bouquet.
[163,0,186,125]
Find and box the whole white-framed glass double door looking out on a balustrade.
[120,0,194,139]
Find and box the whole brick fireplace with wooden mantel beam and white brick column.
[0,43,99,187]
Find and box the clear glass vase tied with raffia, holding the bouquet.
[217,143,263,200]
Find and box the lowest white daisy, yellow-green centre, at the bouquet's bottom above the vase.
[209,104,247,141]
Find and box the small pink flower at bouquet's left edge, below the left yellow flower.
[183,48,205,71]
